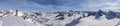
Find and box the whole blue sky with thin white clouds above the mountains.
[0,0,120,12]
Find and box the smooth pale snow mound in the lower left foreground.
[2,16,35,26]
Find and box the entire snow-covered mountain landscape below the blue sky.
[0,10,120,26]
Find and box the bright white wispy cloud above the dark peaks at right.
[77,0,120,12]
